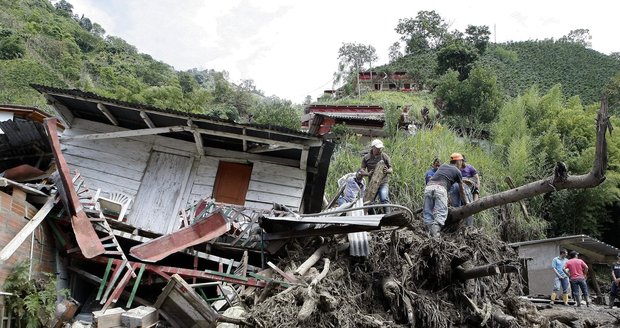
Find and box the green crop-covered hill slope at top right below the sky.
[480,41,620,103]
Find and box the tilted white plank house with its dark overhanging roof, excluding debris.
[33,85,333,234]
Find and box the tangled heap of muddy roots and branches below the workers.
[246,227,560,327]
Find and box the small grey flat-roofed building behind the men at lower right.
[510,235,620,296]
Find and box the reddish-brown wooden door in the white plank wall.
[213,162,252,205]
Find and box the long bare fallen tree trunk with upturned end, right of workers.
[446,98,611,226]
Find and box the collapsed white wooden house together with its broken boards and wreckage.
[2,85,406,327]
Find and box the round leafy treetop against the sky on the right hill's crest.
[395,10,448,54]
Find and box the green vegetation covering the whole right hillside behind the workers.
[325,11,620,246]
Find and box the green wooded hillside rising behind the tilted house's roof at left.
[0,0,300,128]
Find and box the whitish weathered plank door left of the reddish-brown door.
[128,152,192,234]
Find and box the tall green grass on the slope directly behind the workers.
[326,126,545,240]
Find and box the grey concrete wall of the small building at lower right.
[519,242,560,295]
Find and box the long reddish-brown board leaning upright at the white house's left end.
[45,118,105,258]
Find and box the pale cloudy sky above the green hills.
[69,0,620,103]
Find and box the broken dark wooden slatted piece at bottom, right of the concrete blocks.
[155,274,219,328]
